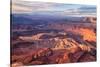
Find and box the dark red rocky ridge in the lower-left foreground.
[11,48,53,64]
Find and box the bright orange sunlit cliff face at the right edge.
[65,28,96,42]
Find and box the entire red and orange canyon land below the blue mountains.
[11,17,96,67]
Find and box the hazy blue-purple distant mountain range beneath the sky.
[11,13,84,25]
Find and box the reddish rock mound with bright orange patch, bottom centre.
[48,49,70,64]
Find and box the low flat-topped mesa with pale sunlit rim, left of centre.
[19,32,66,41]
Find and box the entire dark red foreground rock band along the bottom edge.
[12,48,96,67]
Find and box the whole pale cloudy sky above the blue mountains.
[12,0,96,14]
